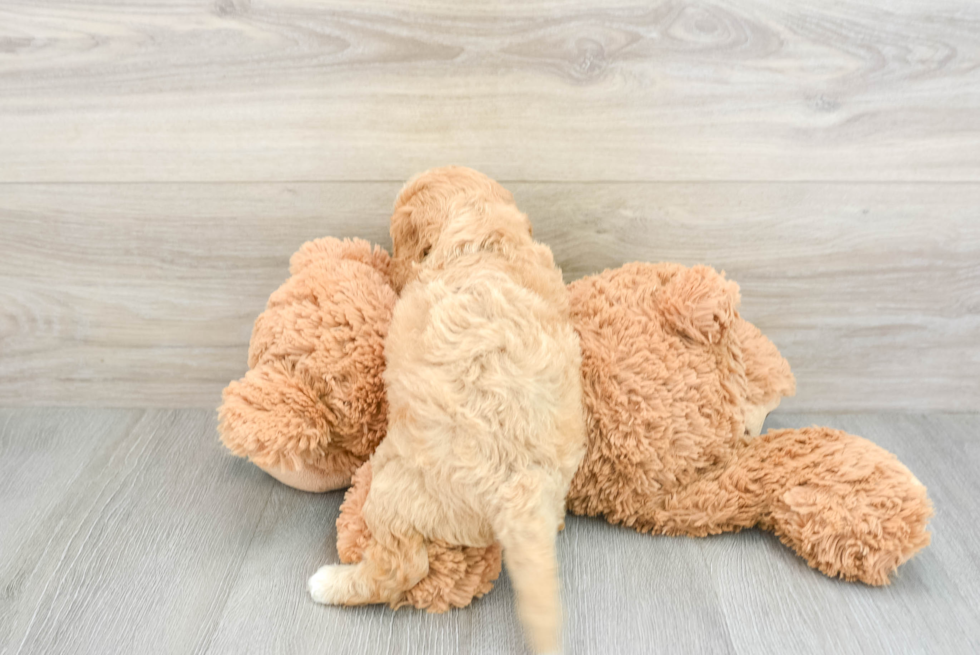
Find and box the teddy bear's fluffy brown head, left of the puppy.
[218,238,397,491]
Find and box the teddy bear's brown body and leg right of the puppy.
[568,264,931,584]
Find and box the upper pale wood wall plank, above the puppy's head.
[0,0,980,182]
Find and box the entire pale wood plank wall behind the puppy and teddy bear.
[0,0,980,411]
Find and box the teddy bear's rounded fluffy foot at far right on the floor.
[747,428,932,585]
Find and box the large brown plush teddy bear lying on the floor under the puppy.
[219,169,932,611]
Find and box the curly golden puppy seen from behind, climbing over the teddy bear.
[310,168,585,652]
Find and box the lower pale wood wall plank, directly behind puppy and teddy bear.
[0,183,980,411]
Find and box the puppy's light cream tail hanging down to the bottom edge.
[493,476,561,653]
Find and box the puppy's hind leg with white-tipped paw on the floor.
[308,526,429,607]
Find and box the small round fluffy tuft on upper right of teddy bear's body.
[658,266,740,344]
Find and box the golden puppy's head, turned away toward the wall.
[391,166,530,291]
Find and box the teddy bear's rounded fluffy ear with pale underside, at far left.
[218,364,362,492]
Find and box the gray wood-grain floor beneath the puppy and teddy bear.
[0,409,980,655]
